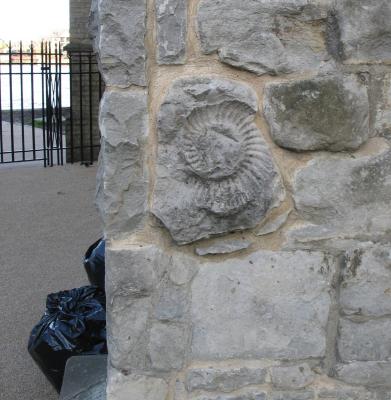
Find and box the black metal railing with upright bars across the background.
[0,42,103,166]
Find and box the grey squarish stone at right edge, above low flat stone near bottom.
[338,318,391,361]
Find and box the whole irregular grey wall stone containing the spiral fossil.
[153,77,281,244]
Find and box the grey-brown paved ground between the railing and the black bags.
[0,165,100,400]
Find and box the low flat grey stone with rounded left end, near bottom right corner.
[336,361,391,388]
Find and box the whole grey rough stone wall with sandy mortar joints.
[92,0,391,400]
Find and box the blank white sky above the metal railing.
[0,0,69,40]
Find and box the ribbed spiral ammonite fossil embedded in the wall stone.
[180,102,273,215]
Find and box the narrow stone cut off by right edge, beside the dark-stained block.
[369,73,391,137]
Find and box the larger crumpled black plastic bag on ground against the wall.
[28,286,107,392]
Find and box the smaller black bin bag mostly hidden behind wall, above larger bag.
[84,239,105,290]
